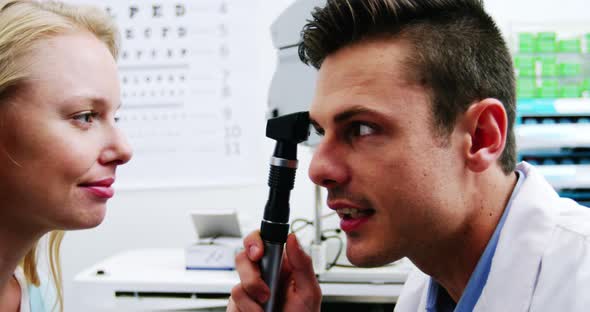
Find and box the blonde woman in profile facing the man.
[0,0,131,312]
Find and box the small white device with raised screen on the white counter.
[185,209,242,270]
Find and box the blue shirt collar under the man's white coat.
[426,170,526,312]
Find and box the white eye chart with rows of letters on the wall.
[70,0,265,189]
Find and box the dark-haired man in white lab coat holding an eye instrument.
[228,0,590,311]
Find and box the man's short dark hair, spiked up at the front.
[299,0,516,174]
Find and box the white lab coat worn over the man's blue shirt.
[395,162,590,312]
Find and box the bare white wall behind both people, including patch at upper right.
[62,0,590,311]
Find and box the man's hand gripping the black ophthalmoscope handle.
[227,231,322,312]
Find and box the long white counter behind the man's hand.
[74,249,411,311]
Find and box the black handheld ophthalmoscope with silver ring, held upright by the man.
[260,112,309,312]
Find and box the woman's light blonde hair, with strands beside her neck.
[0,0,119,311]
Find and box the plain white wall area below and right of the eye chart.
[62,0,313,311]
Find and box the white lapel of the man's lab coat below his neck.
[475,162,559,311]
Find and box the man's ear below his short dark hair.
[461,98,508,172]
